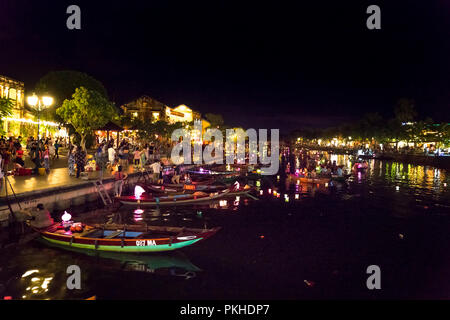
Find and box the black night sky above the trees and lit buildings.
[0,0,450,132]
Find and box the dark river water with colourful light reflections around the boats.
[0,155,450,299]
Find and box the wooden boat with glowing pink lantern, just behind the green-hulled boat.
[115,189,230,206]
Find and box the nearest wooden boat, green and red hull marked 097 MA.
[37,223,220,252]
